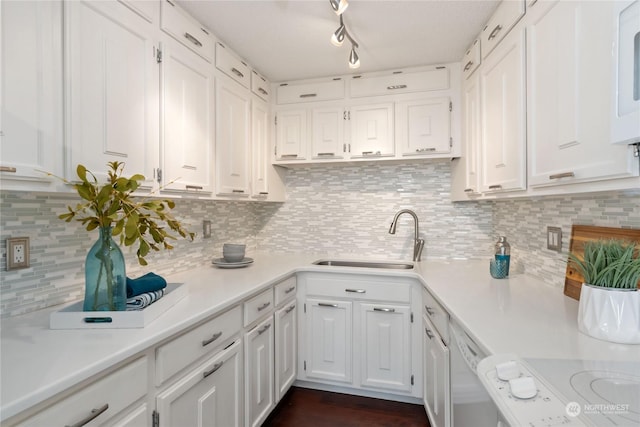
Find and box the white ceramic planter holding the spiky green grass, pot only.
[578,283,640,344]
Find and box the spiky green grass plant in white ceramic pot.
[569,240,640,344]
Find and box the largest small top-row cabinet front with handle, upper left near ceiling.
[160,0,214,62]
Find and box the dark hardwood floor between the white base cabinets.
[262,387,429,427]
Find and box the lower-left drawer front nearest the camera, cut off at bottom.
[20,357,148,427]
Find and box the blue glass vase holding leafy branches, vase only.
[83,227,127,311]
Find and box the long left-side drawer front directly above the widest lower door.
[156,306,242,386]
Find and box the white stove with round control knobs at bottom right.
[478,354,640,427]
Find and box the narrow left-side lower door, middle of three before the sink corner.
[245,316,275,427]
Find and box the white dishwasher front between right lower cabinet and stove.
[449,319,498,427]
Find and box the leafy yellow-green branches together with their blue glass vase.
[51,161,195,311]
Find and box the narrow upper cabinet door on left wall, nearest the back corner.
[251,96,272,198]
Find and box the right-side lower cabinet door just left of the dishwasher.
[422,316,451,427]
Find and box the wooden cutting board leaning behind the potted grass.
[564,224,640,300]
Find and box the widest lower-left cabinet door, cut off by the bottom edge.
[156,340,242,427]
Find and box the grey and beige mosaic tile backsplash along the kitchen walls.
[0,160,640,317]
